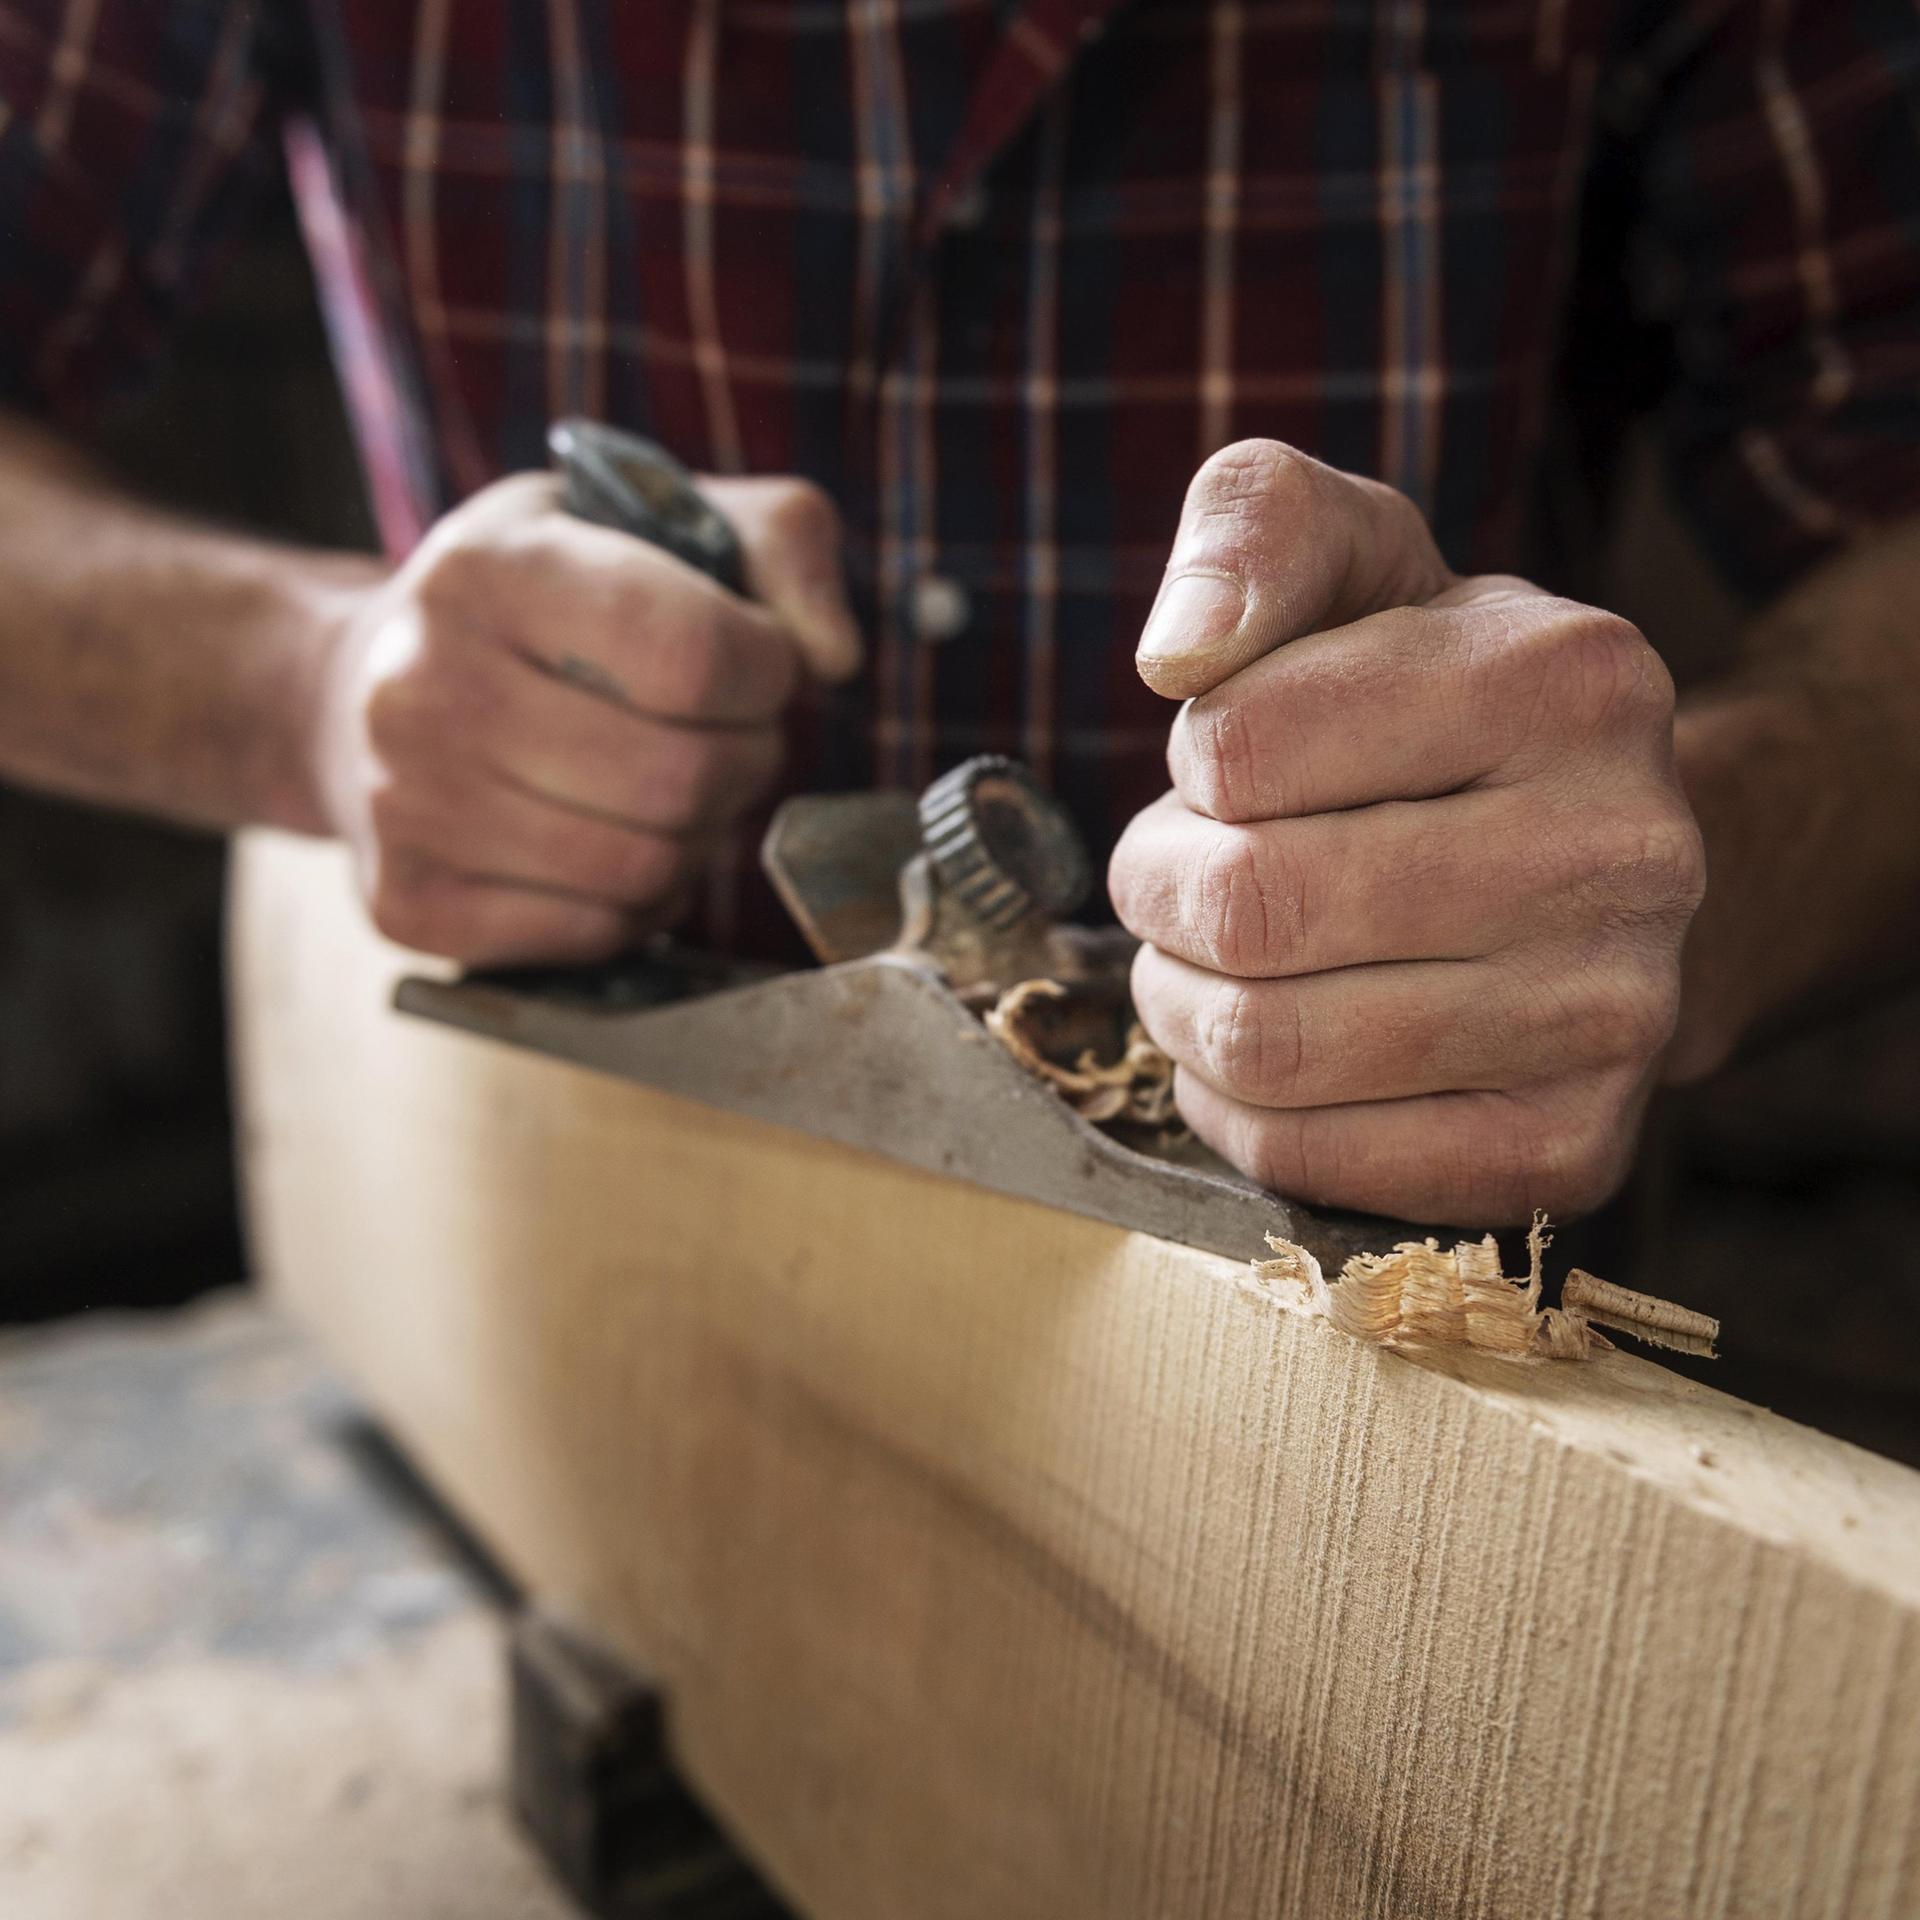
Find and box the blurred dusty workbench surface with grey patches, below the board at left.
[0,1294,572,1920]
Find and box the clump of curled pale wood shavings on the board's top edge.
[1254,1213,1720,1359]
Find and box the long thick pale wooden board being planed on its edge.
[234,837,1920,1920]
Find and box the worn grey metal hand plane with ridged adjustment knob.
[396,422,1409,1267]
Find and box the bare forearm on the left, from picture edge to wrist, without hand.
[0,415,382,831]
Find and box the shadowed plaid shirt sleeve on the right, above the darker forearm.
[1609,0,1920,597]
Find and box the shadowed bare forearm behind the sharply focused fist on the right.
[1667,524,1920,1081]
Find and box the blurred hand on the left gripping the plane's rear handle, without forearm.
[315,474,860,966]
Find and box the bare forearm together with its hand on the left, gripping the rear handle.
[0,417,858,962]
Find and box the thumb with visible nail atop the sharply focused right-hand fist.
[1135,440,1453,701]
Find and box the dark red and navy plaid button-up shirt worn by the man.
[0,0,1920,952]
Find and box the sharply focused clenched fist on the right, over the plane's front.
[1110,440,1705,1225]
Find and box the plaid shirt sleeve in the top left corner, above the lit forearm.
[0,0,276,422]
